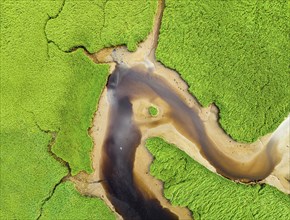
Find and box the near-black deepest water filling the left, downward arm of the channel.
[102,67,177,220]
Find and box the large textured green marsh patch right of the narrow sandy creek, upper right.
[156,0,290,142]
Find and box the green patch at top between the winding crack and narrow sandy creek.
[47,0,157,52]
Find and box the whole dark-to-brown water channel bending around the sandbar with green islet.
[101,65,278,219]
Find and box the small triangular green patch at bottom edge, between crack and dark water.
[40,182,116,220]
